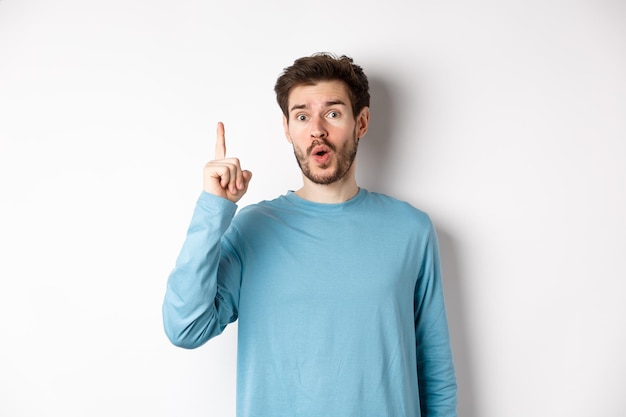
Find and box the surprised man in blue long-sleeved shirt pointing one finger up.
[163,54,456,417]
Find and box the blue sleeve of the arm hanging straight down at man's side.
[414,219,457,417]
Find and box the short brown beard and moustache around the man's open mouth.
[293,133,359,185]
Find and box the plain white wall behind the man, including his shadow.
[0,0,626,417]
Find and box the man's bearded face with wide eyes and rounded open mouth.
[283,81,369,184]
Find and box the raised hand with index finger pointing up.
[204,122,252,203]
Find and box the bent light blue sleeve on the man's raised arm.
[162,192,241,349]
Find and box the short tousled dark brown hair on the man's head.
[274,52,370,117]
